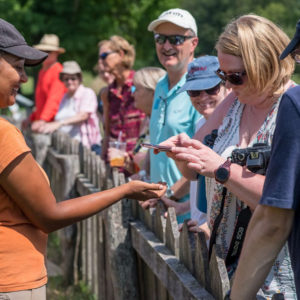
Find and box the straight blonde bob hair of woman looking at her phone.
[216,14,295,96]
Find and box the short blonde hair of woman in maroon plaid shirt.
[98,35,135,69]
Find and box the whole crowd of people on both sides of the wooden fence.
[0,8,300,300]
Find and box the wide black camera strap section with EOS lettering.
[225,206,252,266]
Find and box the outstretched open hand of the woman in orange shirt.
[126,180,167,201]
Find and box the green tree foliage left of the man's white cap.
[0,0,178,70]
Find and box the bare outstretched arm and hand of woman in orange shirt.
[0,152,166,232]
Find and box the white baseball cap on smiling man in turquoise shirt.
[148,8,198,35]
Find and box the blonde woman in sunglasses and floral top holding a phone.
[163,15,296,299]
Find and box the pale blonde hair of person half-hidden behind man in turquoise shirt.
[133,67,166,91]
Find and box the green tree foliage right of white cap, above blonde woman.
[180,0,300,55]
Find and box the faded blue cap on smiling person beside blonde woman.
[177,55,221,93]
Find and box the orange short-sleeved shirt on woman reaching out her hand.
[0,118,47,292]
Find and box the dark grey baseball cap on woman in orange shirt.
[0,19,48,66]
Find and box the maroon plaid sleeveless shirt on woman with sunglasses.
[108,71,145,153]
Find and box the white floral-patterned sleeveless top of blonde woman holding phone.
[206,99,297,299]
